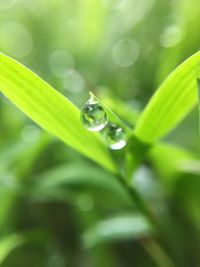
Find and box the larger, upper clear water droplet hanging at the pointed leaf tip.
[81,96,108,132]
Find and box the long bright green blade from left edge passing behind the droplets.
[0,53,116,172]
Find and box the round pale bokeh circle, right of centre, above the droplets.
[112,39,140,67]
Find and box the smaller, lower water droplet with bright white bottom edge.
[103,123,126,150]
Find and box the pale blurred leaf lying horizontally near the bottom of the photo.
[83,214,152,248]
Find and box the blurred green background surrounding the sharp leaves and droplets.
[0,0,200,267]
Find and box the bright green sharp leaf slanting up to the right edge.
[135,52,200,143]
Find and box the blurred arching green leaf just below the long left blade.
[35,163,129,203]
